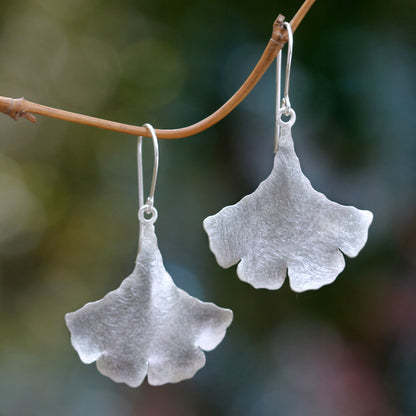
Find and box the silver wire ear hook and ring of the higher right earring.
[274,22,296,153]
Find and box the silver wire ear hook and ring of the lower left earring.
[137,123,159,231]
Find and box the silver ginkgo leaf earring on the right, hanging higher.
[204,22,373,292]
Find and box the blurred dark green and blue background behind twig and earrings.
[0,0,416,416]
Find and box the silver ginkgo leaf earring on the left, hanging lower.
[65,124,233,387]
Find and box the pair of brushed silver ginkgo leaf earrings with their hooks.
[65,23,373,387]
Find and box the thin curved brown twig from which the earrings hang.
[0,0,315,139]
